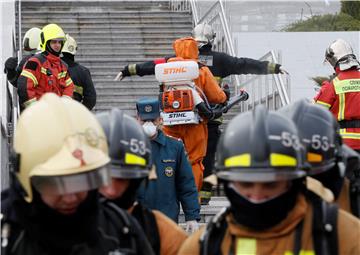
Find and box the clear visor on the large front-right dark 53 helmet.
[217,168,306,182]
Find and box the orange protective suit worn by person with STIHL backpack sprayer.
[163,37,226,190]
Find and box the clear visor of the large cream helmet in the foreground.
[31,167,110,195]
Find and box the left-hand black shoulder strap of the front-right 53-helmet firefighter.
[200,208,228,255]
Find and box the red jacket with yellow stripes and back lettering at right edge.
[314,69,360,150]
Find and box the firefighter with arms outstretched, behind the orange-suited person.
[114,23,287,204]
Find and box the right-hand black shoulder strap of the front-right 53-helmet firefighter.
[312,193,338,255]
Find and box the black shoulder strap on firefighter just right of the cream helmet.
[132,204,160,254]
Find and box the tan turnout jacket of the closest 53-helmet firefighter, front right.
[178,195,360,255]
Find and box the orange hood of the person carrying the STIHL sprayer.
[173,37,199,59]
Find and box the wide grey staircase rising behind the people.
[22,1,192,115]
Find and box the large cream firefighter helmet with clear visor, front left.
[14,93,110,203]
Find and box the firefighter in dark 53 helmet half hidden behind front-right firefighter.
[279,99,360,217]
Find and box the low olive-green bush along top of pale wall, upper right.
[283,13,360,32]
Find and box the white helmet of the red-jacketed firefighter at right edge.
[325,39,359,70]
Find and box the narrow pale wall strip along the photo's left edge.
[0,0,15,190]
